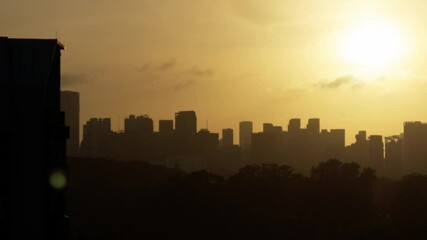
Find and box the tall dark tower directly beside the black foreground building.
[61,91,80,156]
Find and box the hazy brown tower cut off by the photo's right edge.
[403,122,427,175]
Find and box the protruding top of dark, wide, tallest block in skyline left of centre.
[175,111,197,137]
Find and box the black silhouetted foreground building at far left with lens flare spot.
[0,37,68,239]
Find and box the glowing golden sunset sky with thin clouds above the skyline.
[0,0,427,144]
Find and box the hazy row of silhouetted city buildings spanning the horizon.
[62,91,427,178]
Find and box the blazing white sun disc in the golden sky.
[341,21,404,68]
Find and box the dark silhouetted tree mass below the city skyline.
[67,158,427,239]
